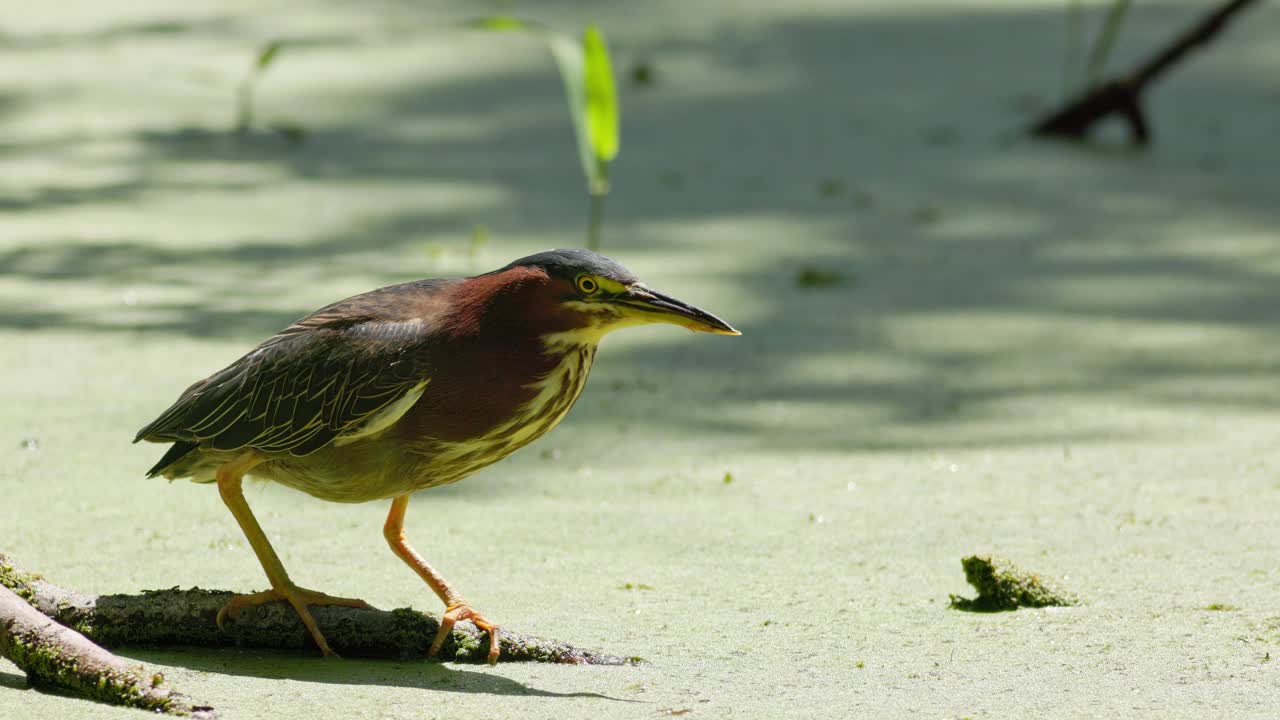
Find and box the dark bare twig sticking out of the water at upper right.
[1032,0,1257,145]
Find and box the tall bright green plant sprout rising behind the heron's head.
[467,15,621,250]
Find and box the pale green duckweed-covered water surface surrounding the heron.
[0,0,1280,717]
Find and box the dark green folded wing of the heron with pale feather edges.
[134,306,430,456]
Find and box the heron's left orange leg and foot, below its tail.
[218,451,369,655]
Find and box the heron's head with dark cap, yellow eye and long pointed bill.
[477,250,741,343]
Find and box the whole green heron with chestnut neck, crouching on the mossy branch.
[134,250,739,662]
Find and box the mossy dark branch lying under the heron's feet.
[0,553,635,665]
